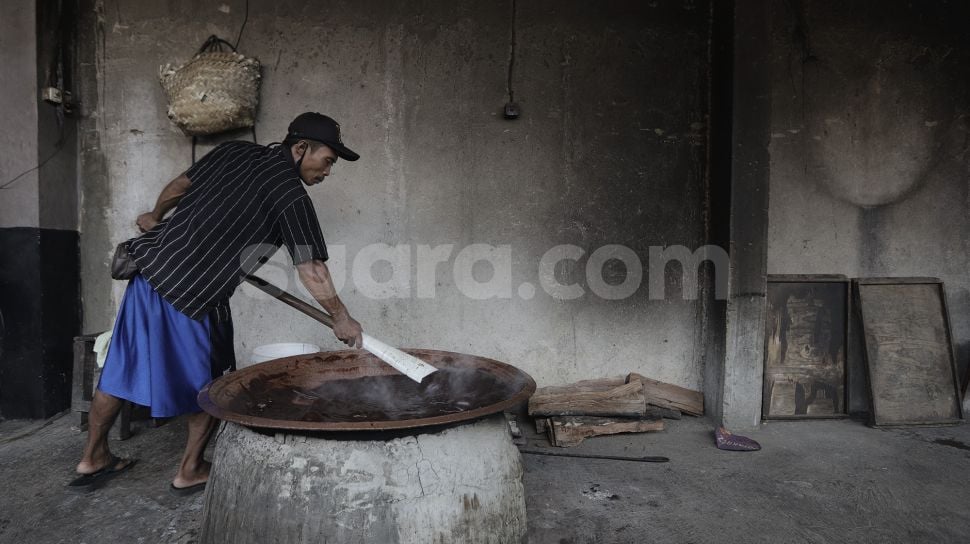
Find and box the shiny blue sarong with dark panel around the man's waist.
[98,274,235,417]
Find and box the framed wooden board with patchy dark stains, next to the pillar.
[761,275,851,419]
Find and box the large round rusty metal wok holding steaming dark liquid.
[198,349,536,431]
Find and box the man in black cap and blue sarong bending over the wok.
[69,112,362,494]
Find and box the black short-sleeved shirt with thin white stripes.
[128,142,327,321]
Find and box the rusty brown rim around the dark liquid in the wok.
[198,348,536,431]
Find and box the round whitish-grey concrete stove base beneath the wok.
[201,414,527,544]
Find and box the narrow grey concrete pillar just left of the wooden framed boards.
[711,0,771,429]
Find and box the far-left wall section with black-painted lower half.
[0,0,80,418]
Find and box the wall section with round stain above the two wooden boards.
[768,1,970,408]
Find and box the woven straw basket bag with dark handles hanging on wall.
[159,36,260,136]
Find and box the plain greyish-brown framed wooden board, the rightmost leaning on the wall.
[853,278,963,426]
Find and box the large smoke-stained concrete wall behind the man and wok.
[81,0,709,389]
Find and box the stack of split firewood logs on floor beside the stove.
[529,373,704,448]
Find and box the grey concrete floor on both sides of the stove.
[0,416,970,544]
